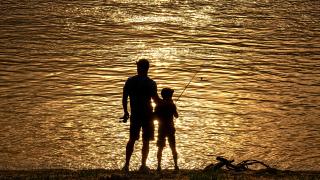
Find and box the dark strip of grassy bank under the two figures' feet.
[0,169,320,180]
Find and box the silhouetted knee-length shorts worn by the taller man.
[130,120,154,141]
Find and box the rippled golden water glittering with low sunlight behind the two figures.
[0,0,320,170]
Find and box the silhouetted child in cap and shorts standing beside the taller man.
[155,88,179,171]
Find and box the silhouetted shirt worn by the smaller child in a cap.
[155,100,178,127]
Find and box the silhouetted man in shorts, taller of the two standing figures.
[122,59,160,172]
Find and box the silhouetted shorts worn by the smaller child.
[157,127,176,147]
